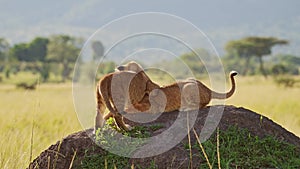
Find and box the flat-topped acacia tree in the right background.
[225,36,288,77]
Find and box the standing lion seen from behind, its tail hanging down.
[95,62,160,131]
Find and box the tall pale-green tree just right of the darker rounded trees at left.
[46,35,82,81]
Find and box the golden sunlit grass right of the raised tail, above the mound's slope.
[226,77,300,136]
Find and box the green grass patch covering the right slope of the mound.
[193,126,300,168]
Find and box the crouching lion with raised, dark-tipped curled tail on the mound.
[125,71,237,113]
